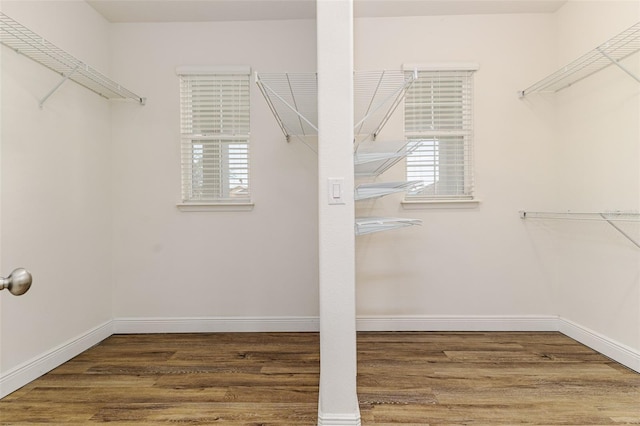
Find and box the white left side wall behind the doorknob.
[0,1,112,393]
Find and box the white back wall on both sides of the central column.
[111,15,557,326]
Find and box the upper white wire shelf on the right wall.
[519,22,640,98]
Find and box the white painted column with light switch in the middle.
[317,0,360,426]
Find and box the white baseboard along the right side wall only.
[558,318,640,373]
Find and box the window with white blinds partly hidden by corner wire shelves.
[404,67,476,201]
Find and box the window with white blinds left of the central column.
[178,67,250,204]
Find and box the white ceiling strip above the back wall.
[87,0,566,22]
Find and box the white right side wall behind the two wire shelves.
[553,1,640,352]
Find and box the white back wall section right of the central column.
[355,14,557,316]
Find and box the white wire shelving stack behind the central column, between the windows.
[255,70,422,235]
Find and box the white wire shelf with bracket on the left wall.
[0,12,145,107]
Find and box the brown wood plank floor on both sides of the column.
[0,332,640,426]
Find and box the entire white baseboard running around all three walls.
[0,315,640,400]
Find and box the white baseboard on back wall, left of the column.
[113,317,320,334]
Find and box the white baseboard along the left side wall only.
[0,321,113,398]
